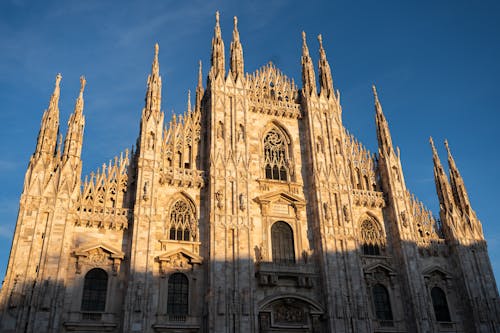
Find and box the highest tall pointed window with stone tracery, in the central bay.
[264,128,289,181]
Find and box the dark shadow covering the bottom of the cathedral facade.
[0,237,500,332]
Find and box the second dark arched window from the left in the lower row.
[167,273,189,316]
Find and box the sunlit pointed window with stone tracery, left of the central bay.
[165,192,199,241]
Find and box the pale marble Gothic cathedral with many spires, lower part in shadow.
[0,13,500,333]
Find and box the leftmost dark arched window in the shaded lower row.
[81,268,108,312]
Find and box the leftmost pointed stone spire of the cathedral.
[35,74,62,155]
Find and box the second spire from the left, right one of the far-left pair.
[63,76,87,160]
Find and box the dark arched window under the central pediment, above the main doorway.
[271,221,295,264]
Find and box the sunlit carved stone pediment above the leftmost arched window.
[73,243,125,274]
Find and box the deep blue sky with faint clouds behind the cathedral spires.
[0,0,500,280]
